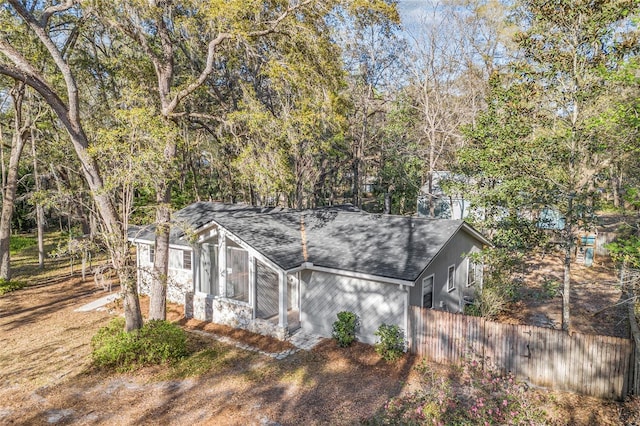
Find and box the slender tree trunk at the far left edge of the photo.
[0,81,29,281]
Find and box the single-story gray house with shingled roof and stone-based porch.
[130,202,489,343]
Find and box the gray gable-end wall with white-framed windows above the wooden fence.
[410,231,482,312]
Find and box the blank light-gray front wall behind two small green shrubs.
[300,271,406,344]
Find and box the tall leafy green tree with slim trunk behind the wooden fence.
[462,0,640,330]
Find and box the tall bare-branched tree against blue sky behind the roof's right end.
[404,0,509,217]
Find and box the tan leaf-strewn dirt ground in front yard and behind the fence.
[0,248,637,425]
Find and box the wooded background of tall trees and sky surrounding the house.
[0,0,640,329]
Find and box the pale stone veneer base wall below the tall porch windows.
[190,293,287,340]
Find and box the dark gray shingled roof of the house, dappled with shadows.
[129,202,488,281]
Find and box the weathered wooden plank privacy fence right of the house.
[408,306,634,399]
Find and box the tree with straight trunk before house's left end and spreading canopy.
[94,0,394,319]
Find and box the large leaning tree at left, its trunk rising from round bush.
[0,0,142,331]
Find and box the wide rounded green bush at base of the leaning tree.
[91,318,187,371]
